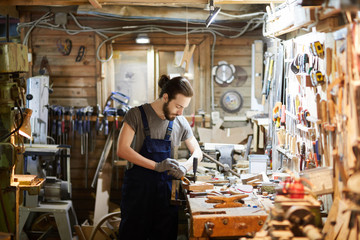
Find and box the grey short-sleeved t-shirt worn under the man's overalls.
[124,103,193,158]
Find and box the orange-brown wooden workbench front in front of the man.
[186,195,268,240]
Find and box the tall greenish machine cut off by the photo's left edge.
[0,42,28,239]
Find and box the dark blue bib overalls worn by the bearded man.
[119,106,178,240]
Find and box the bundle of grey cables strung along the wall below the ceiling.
[17,12,266,78]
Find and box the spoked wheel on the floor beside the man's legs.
[90,212,121,240]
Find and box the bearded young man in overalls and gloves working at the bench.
[117,75,202,240]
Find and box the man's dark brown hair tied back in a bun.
[158,75,194,101]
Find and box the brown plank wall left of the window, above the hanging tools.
[31,15,100,107]
